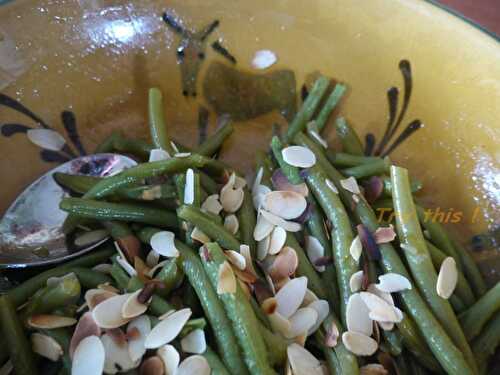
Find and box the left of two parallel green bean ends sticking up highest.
[286,76,330,141]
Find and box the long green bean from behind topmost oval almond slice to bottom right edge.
[295,133,473,375]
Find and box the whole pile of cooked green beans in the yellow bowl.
[0,83,500,375]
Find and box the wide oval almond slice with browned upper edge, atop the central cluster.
[263,190,307,220]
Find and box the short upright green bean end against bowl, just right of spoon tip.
[148,87,175,156]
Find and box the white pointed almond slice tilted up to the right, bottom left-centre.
[144,308,191,349]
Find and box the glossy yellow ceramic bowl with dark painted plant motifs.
[0,0,500,280]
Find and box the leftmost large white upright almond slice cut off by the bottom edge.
[71,336,105,375]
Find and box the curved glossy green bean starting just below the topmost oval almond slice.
[306,165,358,324]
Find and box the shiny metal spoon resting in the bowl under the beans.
[0,154,137,268]
